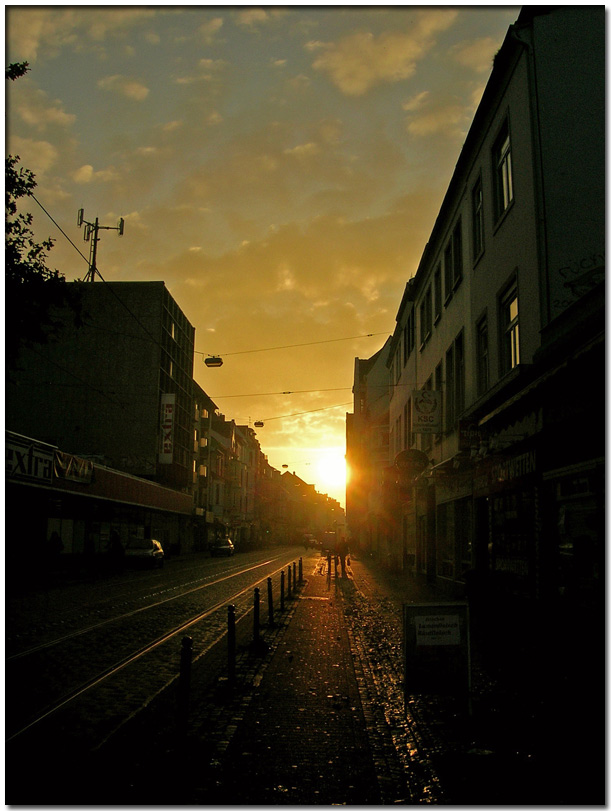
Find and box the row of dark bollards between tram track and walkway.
[178,558,303,737]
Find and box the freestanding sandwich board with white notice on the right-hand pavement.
[403,603,471,699]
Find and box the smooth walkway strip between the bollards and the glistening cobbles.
[193,558,381,805]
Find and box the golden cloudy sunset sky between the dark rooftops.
[5,5,519,505]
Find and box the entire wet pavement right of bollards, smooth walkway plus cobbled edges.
[44,556,604,806]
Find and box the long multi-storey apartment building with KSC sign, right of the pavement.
[348,7,605,616]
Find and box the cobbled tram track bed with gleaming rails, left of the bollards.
[6,556,304,748]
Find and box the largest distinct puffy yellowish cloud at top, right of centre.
[314,10,457,96]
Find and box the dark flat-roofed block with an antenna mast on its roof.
[6,282,195,492]
